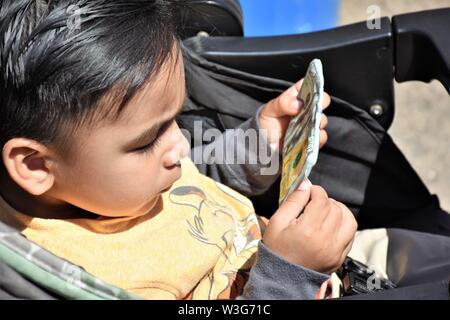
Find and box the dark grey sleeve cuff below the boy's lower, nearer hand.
[238,242,330,300]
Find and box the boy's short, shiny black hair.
[0,0,183,155]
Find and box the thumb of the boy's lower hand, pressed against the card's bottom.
[270,179,312,229]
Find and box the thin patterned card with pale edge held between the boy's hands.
[279,59,324,204]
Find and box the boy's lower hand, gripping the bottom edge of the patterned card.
[263,181,358,274]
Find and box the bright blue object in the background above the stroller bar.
[241,0,339,37]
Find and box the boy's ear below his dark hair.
[2,138,55,196]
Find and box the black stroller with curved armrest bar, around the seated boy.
[0,0,450,299]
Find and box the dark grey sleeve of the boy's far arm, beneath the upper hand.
[191,106,281,196]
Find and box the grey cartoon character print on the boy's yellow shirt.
[169,183,261,299]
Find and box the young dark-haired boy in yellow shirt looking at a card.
[0,0,356,299]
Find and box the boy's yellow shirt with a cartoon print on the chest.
[0,159,268,299]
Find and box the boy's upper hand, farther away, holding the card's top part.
[259,79,331,150]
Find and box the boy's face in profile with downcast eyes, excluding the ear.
[52,53,189,217]
